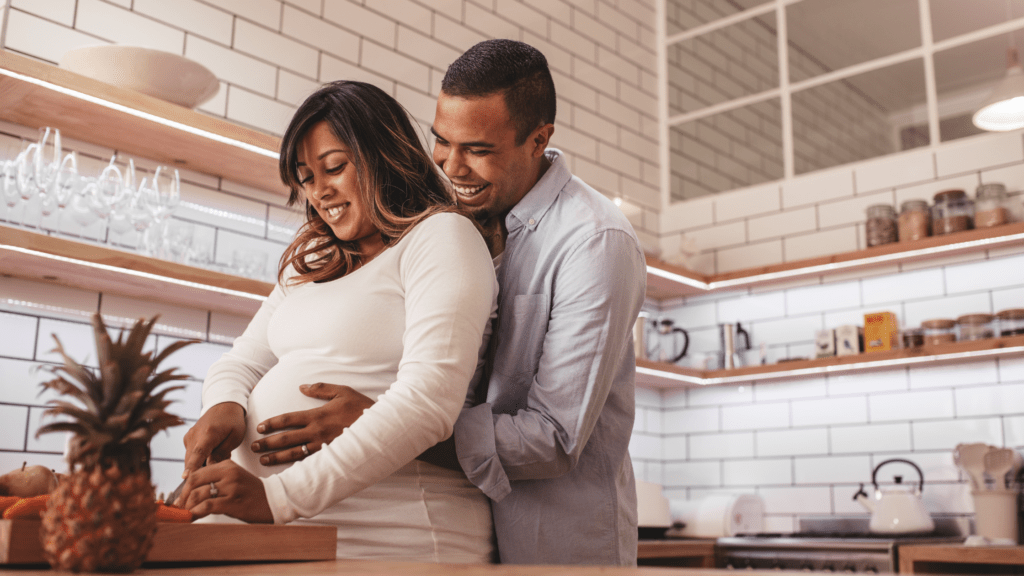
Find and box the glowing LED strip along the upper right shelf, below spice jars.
[647,229,1024,291]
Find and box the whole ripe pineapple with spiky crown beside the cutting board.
[36,314,193,572]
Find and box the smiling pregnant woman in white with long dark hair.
[177,82,497,562]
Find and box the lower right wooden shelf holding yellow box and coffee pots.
[636,336,1024,388]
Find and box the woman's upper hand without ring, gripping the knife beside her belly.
[181,402,246,478]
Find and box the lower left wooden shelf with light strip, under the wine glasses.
[0,225,273,316]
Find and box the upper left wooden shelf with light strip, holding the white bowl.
[0,50,288,196]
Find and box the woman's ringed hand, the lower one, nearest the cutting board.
[174,460,273,524]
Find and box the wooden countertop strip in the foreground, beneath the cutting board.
[2,560,779,576]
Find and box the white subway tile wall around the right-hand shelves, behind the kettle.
[635,132,1024,532]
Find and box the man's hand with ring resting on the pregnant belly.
[252,382,374,466]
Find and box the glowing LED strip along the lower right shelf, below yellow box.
[637,346,1024,386]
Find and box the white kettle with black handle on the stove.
[853,458,935,534]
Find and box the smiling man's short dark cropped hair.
[441,39,555,146]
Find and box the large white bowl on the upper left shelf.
[59,45,220,108]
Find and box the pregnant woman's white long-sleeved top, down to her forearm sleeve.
[203,213,498,523]
